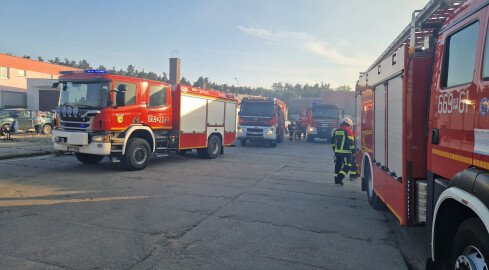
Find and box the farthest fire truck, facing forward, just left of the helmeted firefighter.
[301,103,345,142]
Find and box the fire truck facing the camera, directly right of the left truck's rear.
[238,97,286,147]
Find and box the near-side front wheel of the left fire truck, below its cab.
[121,138,151,171]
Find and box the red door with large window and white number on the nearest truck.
[428,9,486,179]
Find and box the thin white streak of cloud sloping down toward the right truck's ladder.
[238,26,371,67]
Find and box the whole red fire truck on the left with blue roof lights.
[53,70,237,170]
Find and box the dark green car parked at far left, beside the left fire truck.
[0,109,54,136]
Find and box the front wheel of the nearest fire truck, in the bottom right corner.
[451,217,489,269]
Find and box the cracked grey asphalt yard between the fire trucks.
[0,138,429,269]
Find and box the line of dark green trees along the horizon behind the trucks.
[7,53,352,104]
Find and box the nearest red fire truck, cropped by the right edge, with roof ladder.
[355,0,489,269]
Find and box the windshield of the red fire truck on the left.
[60,82,110,108]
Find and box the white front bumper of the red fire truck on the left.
[53,130,111,156]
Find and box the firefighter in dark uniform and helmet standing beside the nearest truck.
[331,117,355,185]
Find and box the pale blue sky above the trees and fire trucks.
[0,0,428,88]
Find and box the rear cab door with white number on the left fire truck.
[145,85,172,129]
